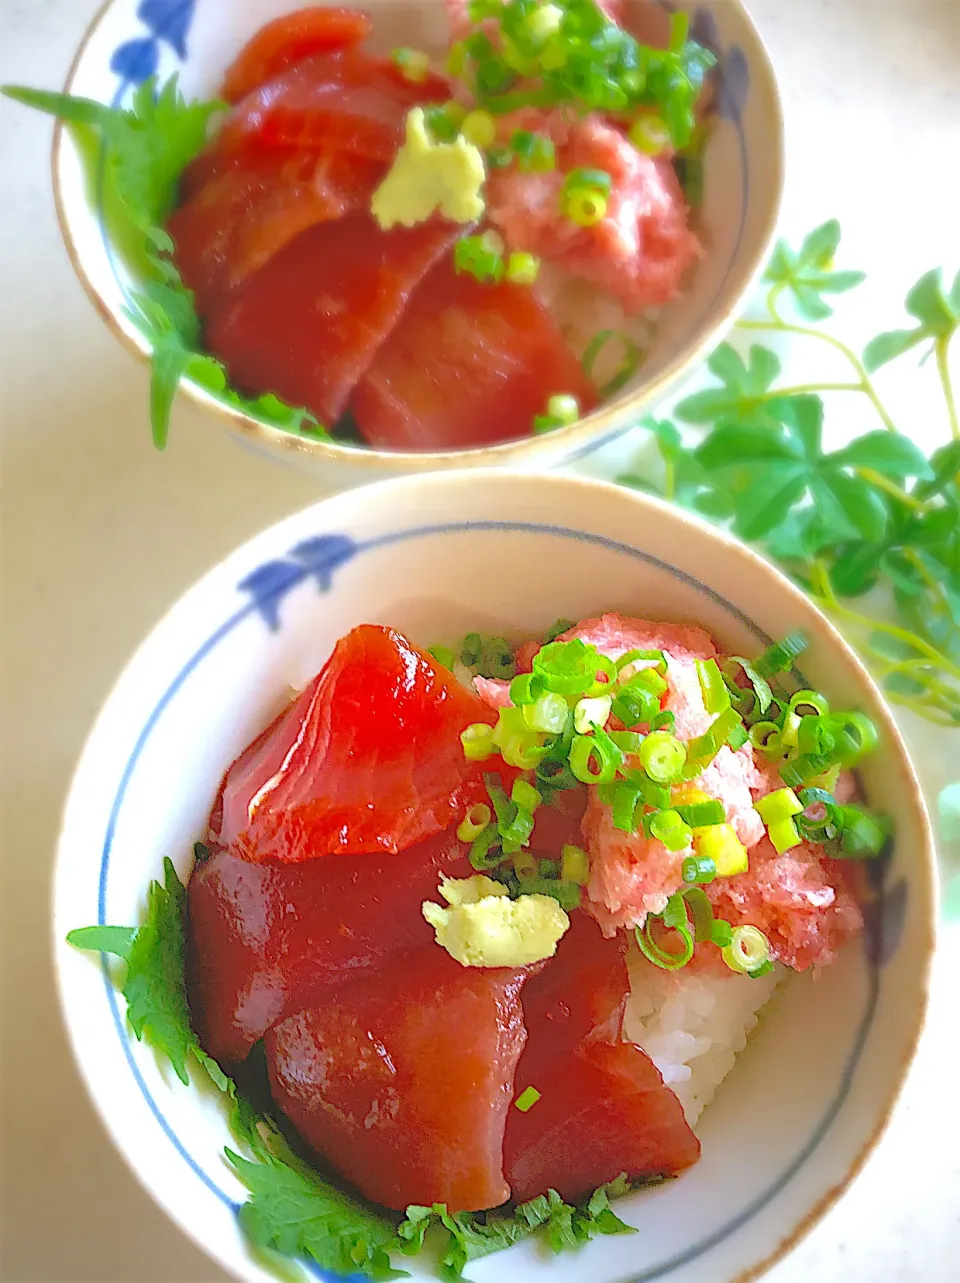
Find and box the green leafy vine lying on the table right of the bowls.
[617,221,960,726]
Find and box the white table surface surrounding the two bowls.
[0,0,960,1283]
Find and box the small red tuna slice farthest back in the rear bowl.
[221,5,373,103]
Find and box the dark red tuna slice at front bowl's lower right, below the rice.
[503,1042,699,1202]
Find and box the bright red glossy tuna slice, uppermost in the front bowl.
[210,624,493,862]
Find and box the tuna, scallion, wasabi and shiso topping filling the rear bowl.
[13,0,716,452]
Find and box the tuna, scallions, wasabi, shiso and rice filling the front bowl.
[69,613,891,1278]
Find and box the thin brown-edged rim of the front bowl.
[51,467,939,1283]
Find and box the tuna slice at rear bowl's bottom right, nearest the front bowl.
[350,262,597,450]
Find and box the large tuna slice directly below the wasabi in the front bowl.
[266,948,525,1211]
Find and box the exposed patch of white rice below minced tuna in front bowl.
[624,948,784,1126]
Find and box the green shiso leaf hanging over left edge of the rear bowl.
[3,76,329,450]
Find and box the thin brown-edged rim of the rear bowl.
[50,0,785,480]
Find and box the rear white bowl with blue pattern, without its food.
[54,0,783,486]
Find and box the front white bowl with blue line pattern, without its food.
[54,471,936,1283]
